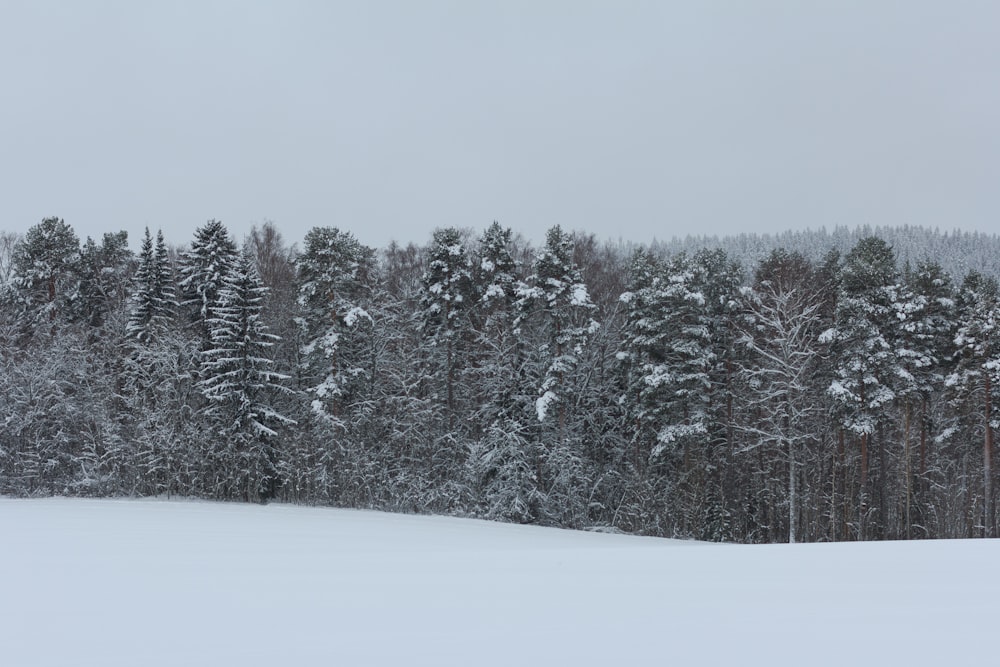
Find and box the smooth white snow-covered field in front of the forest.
[0,499,1000,667]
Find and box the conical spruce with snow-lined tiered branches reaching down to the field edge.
[198,255,292,501]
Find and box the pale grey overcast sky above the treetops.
[0,0,1000,252]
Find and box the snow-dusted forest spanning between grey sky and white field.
[0,218,1000,542]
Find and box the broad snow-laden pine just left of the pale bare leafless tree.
[619,254,727,539]
